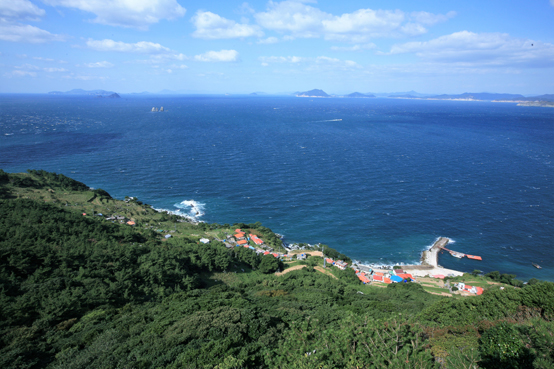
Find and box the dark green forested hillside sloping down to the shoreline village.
[0,171,554,369]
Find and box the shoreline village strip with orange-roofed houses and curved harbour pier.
[4,171,494,296]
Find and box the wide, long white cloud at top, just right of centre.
[254,1,450,43]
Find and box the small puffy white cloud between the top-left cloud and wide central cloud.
[191,10,263,39]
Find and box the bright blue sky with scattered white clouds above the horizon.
[0,0,554,95]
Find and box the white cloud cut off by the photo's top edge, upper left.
[43,0,186,30]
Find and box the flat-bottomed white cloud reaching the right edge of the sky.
[389,31,554,67]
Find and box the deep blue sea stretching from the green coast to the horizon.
[0,94,554,281]
